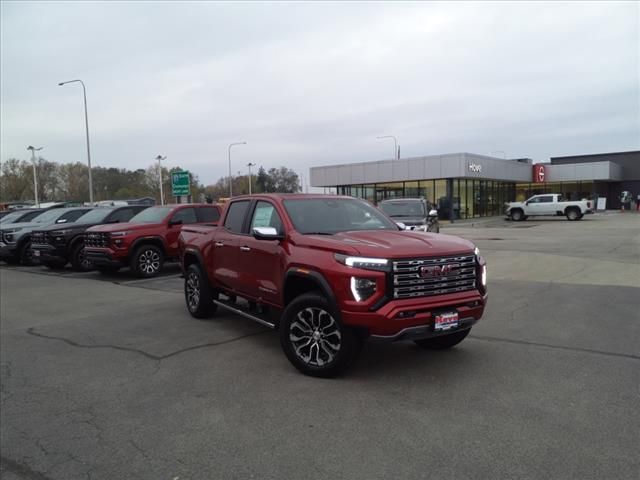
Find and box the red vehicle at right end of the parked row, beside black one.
[84,204,221,277]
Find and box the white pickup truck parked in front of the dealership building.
[505,193,593,222]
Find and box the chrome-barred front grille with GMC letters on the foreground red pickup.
[393,255,476,298]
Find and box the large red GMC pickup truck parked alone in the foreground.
[179,194,487,377]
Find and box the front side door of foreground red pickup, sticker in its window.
[239,200,284,305]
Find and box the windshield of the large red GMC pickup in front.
[284,198,398,235]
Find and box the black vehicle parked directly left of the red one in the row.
[31,205,147,272]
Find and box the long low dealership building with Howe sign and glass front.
[310,151,640,218]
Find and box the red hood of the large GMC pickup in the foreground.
[295,230,475,258]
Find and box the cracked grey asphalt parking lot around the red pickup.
[0,213,640,480]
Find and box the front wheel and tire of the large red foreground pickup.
[279,293,362,378]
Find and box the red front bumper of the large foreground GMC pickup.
[341,290,488,341]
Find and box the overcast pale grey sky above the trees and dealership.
[0,1,640,184]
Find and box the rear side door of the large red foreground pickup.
[211,200,250,292]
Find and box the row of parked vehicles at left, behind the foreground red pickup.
[0,204,220,277]
